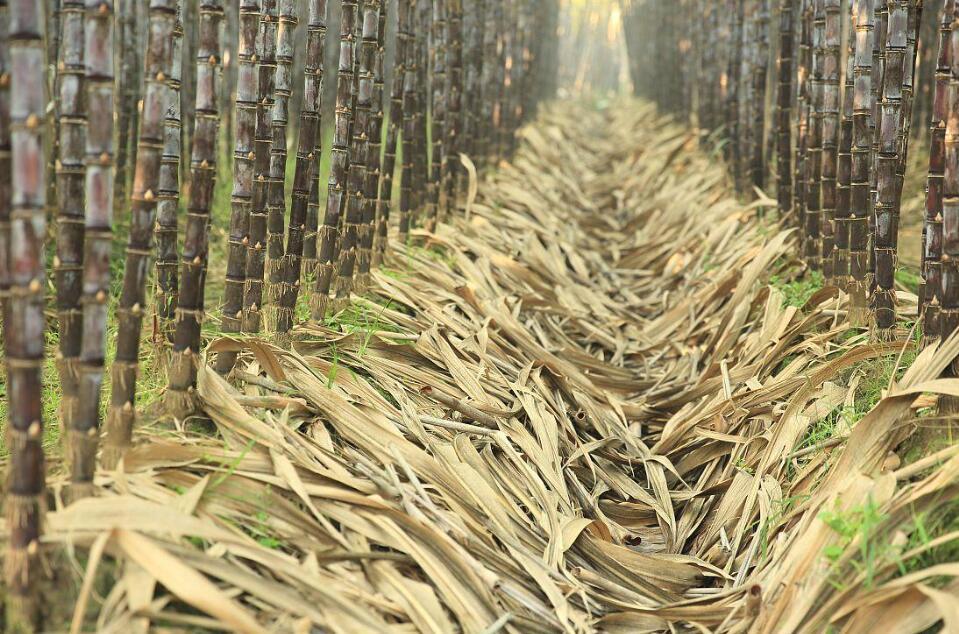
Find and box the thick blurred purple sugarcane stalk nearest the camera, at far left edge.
[3,0,48,631]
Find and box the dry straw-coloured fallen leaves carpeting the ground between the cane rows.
[26,102,959,633]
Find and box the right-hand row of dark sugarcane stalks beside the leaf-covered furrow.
[625,0,959,341]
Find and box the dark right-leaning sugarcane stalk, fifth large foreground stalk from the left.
[166,0,224,419]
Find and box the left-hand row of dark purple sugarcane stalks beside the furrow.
[0,0,559,629]
